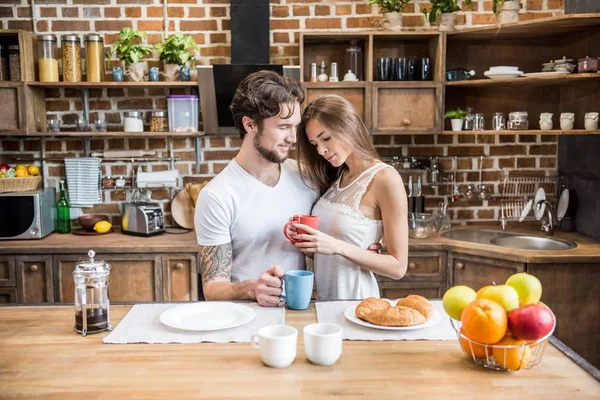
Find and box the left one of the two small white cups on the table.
[250,325,298,368]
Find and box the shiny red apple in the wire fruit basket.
[508,304,554,340]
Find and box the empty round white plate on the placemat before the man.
[160,301,256,331]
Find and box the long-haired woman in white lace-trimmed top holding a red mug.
[292,95,408,300]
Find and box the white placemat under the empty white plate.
[103,303,285,344]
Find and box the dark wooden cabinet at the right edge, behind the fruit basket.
[527,263,600,368]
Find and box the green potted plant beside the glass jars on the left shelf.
[107,28,152,82]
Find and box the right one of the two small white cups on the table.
[304,323,342,365]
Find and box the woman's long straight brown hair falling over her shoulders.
[297,94,379,195]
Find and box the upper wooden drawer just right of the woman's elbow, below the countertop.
[377,251,447,283]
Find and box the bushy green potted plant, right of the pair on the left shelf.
[154,33,198,81]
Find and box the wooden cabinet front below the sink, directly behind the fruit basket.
[449,253,525,290]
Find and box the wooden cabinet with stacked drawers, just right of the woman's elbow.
[376,251,448,299]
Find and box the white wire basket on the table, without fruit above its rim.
[450,313,556,372]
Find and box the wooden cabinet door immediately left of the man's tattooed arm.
[162,254,198,301]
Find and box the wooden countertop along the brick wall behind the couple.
[0,225,600,263]
